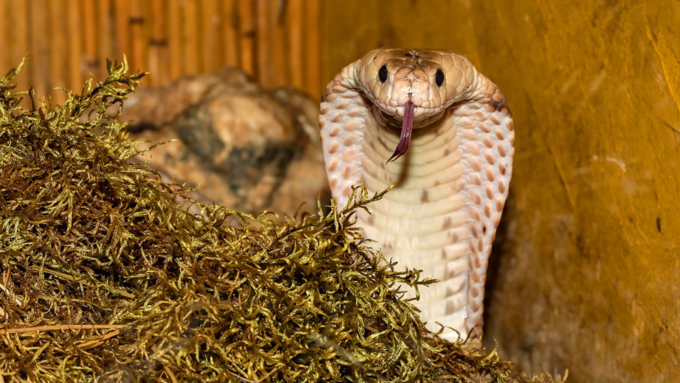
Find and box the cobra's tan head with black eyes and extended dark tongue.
[355,49,476,162]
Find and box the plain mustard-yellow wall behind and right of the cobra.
[321,0,680,382]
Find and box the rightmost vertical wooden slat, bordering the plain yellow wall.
[304,0,323,97]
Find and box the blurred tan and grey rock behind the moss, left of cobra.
[122,68,330,214]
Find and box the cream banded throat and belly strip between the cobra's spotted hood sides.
[358,109,479,336]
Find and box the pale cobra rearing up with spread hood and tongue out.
[319,49,515,341]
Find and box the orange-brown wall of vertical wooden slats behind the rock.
[0,0,322,102]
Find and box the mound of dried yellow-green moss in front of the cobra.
[0,57,564,382]
